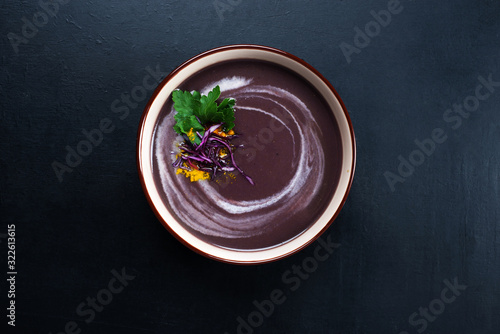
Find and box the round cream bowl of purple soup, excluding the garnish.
[137,45,356,264]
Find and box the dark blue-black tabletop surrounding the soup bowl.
[0,0,500,334]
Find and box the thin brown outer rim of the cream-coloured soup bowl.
[136,44,356,265]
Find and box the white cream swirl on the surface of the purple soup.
[154,77,325,239]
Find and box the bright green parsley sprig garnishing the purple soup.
[172,86,235,140]
